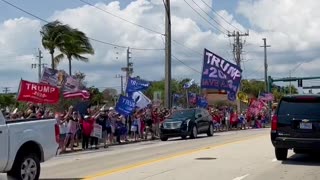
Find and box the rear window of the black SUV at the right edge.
[278,99,320,116]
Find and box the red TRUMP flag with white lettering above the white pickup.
[17,80,60,104]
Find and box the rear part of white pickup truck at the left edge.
[0,111,59,180]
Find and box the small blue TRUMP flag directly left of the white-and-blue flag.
[115,95,136,116]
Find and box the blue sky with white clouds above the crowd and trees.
[0,0,320,94]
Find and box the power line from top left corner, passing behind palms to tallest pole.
[1,0,164,51]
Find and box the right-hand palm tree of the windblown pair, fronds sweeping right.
[56,29,94,76]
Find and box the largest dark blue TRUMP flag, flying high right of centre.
[201,49,242,101]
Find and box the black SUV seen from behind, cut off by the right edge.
[271,95,320,160]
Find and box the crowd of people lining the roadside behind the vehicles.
[2,103,268,153]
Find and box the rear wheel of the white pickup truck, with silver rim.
[8,154,40,180]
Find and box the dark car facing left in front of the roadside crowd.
[160,108,213,141]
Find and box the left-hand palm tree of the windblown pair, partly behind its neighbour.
[40,21,71,69]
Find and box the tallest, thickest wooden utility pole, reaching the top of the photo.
[164,0,172,109]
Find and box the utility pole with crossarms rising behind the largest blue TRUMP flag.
[228,31,249,112]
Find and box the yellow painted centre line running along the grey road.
[82,134,269,180]
